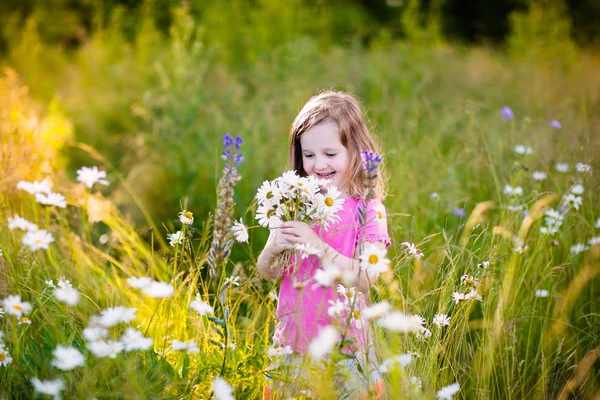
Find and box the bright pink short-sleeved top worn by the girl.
[273,197,390,354]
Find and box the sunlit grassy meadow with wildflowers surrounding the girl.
[0,1,600,399]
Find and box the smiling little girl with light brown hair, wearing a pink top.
[257,91,390,398]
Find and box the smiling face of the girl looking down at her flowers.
[300,120,350,192]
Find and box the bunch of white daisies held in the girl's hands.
[256,171,344,230]
